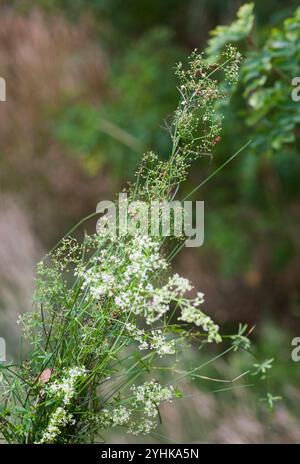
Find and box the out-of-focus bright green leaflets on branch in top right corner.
[213,4,300,154]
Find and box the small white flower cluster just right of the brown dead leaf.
[48,367,87,405]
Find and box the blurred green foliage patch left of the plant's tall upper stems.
[55,28,183,179]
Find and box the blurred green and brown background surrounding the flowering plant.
[0,0,300,443]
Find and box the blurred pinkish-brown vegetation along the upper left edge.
[0,11,108,246]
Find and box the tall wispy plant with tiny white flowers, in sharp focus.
[0,47,245,443]
